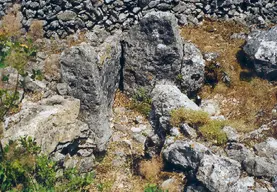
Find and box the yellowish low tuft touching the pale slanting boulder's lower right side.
[170,108,210,127]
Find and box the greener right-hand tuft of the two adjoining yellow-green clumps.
[199,120,227,145]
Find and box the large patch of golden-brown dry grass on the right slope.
[182,21,277,131]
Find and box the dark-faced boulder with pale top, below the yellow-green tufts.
[162,140,211,172]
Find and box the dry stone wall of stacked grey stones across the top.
[0,0,277,37]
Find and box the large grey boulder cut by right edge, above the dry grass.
[243,26,277,80]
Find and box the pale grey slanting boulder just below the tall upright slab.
[151,84,200,132]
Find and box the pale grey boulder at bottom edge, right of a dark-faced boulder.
[196,154,241,192]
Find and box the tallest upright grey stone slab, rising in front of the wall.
[124,12,183,91]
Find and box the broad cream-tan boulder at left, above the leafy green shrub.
[1,96,88,154]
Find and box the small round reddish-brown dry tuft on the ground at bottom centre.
[139,157,163,182]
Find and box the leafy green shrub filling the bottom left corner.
[0,137,94,192]
